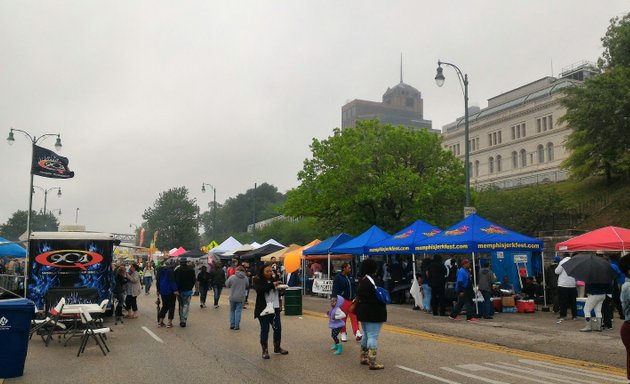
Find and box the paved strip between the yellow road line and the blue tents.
[303,296,626,368]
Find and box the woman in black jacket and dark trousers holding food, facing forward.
[254,265,289,359]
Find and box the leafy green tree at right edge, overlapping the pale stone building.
[560,15,630,184]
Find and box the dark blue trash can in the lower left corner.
[0,299,35,379]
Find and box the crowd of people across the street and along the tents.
[107,249,630,378]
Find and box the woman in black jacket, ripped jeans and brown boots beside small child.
[356,259,387,370]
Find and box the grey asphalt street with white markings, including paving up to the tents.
[6,291,627,384]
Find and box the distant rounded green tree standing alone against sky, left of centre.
[142,187,199,250]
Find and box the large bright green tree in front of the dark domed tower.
[284,120,464,234]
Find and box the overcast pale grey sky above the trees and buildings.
[0,0,629,237]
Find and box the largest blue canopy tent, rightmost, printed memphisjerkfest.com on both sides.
[415,214,543,310]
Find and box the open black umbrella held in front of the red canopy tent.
[562,253,617,284]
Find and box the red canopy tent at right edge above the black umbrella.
[556,227,630,252]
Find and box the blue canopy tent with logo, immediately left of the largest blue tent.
[366,220,442,276]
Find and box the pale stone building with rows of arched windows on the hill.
[442,62,596,189]
